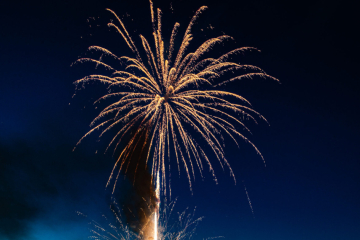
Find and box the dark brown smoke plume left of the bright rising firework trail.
[122,128,158,239]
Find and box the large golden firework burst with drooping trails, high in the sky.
[75,0,278,194]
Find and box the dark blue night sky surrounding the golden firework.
[0,0,360,240]
